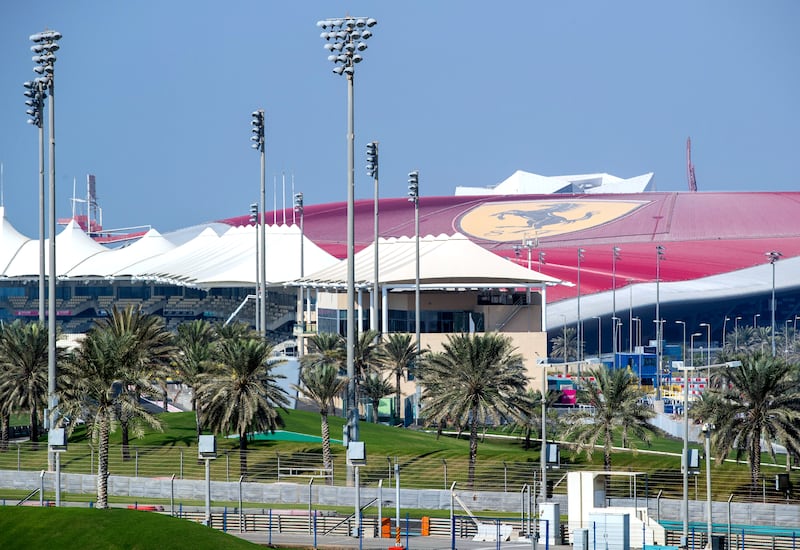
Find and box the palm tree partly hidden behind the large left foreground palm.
[97,306,176,460]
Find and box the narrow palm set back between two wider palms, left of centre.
[175,319,216,437]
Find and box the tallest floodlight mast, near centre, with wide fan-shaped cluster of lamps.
[317,16,377,460]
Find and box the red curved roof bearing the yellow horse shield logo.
[223,192,800,301]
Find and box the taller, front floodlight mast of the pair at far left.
[30,30,61,440]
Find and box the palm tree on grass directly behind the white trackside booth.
[564,367,655,470]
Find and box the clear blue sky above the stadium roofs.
[0,0,800,236]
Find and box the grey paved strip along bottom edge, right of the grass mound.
[229,531,571,550]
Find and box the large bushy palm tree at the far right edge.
[689,351,800,490]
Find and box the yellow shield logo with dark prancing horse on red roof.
[459,199,646,242]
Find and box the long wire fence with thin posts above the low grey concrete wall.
[0,442,800,504]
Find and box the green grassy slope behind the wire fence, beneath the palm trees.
[0,411,800,506]
